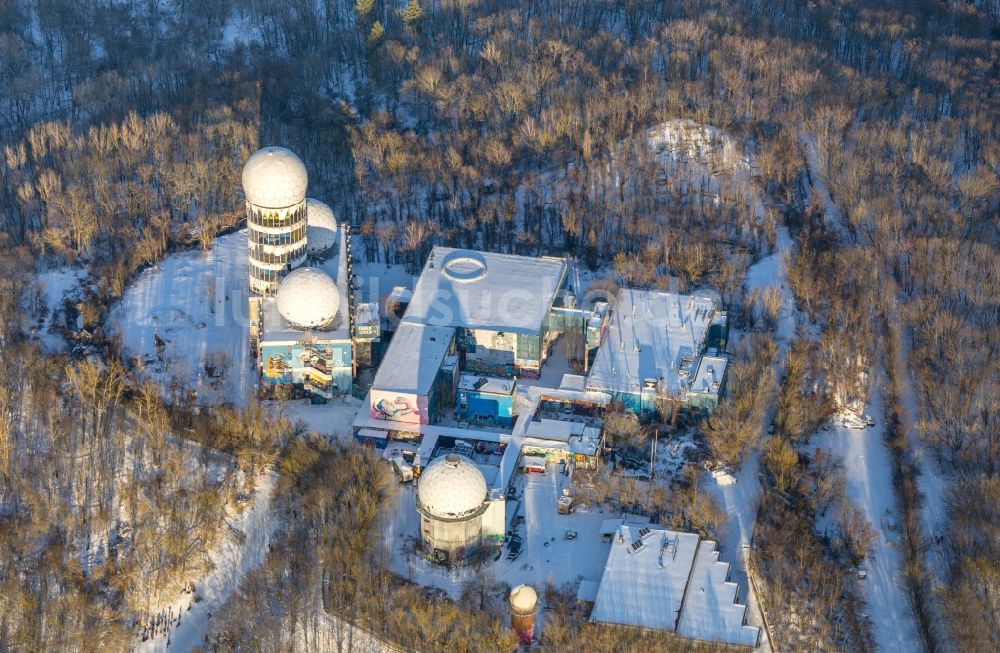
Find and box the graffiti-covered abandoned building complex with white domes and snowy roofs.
[243,147,759,646]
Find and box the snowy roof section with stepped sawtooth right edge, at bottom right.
[677,540,760,646]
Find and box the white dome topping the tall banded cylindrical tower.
[243,147,309,209]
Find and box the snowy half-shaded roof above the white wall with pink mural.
[372,322,455,395]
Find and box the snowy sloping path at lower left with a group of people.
[135,472,277,653]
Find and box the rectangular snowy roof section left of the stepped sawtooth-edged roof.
[590,523,699,631]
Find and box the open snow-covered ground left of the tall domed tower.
[108,231,256,405]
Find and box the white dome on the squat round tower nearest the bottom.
[417,453,486,519]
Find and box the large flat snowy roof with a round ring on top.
[404,247,566,334]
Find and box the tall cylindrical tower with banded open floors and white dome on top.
[243,147,309,295]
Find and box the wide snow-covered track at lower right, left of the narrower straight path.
[809,391,921,653]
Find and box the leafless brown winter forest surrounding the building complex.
[0,0,1000,653]
